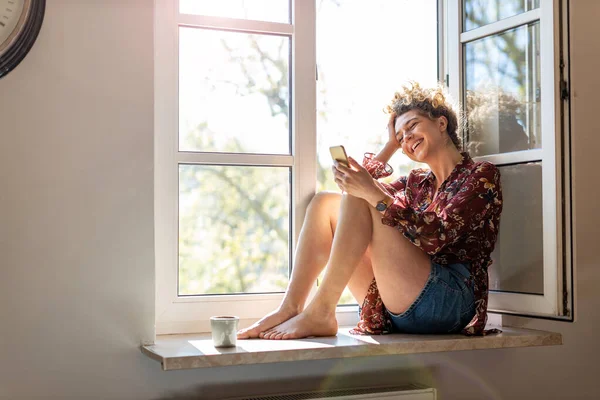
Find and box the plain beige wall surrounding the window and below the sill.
[0,0,600,400]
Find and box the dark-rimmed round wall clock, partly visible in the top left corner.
[0,0,46,78]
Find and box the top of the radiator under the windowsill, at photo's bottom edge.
[239,385,437,400]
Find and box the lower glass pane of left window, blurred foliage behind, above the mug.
[179,165,290,295]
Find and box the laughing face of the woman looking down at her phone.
[395,110,449,163]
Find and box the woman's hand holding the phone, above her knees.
[332,157,386,205]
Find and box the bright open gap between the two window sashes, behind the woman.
[317,0,438,303]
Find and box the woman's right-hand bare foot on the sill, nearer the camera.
[261,309,338,340]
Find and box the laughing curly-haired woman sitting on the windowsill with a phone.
[238,83,502,339]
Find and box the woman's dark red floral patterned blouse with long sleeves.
[352,153,502,335]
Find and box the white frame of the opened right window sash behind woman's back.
[443,0,572,319]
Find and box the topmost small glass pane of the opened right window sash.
[463,0,540,31]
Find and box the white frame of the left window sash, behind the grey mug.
[154,0,317,334]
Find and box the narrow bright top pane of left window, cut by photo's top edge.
[179,0,290,23]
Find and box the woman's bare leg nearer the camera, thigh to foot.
[261,195,431,339]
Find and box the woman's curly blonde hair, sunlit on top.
[384,81,462,151]
